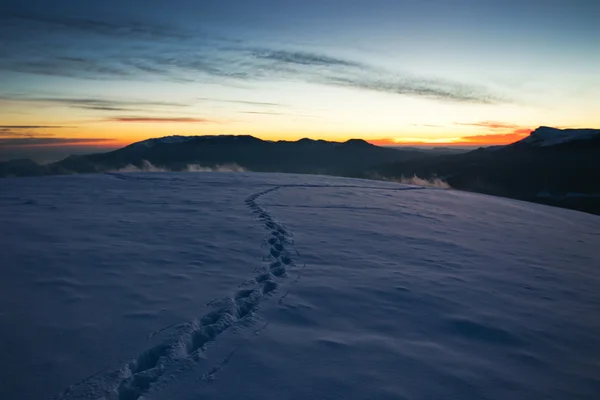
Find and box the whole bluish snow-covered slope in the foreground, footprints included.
[0,173,600,400]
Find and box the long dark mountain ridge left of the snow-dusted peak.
[0,135,422,176]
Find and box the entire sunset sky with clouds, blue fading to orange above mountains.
[0,0,600,162]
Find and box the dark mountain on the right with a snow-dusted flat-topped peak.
[376,127,600,213]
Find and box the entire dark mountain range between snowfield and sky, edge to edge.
[0,126,600,214]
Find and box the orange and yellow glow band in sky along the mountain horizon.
[0,117,544,151]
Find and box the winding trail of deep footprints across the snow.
[58,187,293,400]
